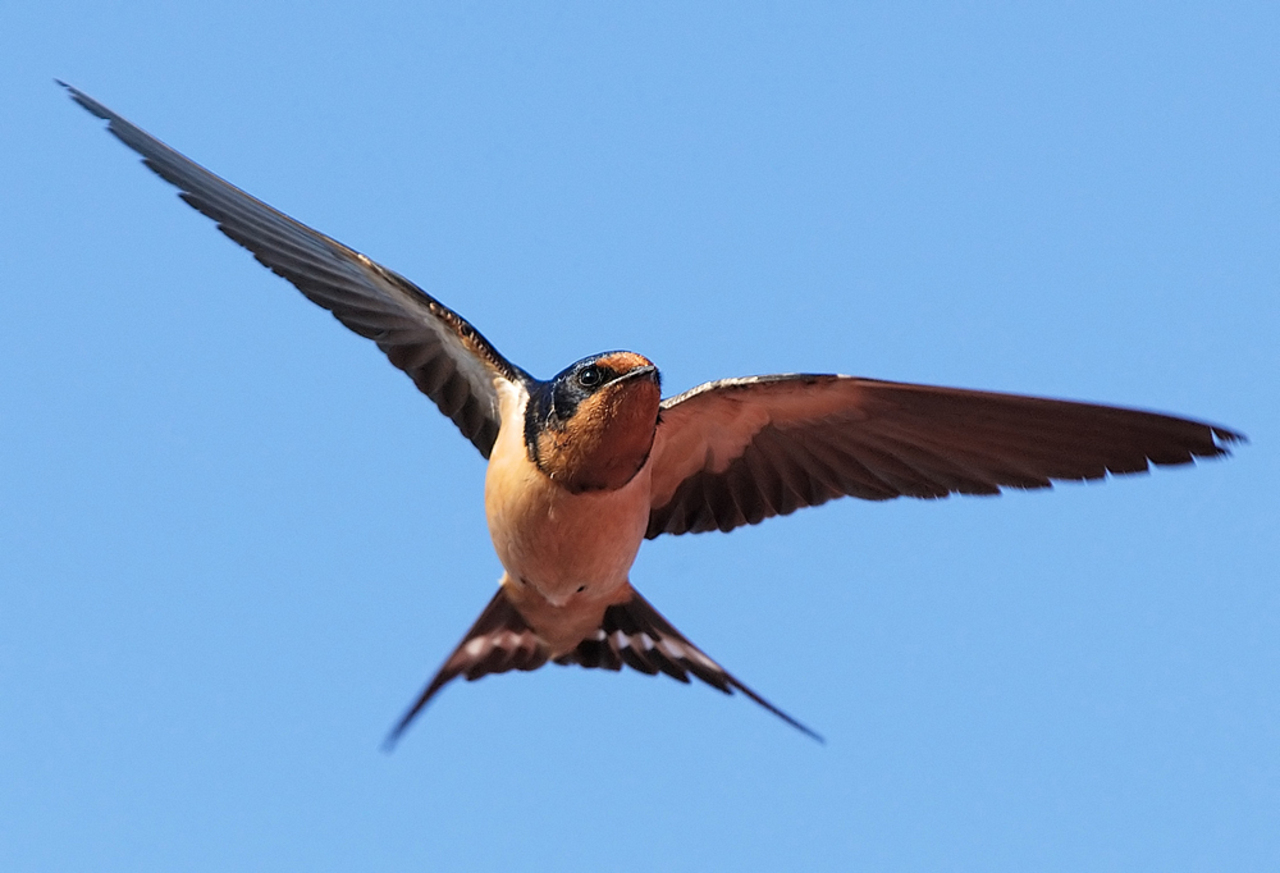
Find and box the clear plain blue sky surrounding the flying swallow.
[0,1,1280,870]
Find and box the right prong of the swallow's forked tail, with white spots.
[556,590,823,742]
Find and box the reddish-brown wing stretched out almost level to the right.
[646,375,1243,538]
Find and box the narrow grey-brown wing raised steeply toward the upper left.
[59,82,529,457]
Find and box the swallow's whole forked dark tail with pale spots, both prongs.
[384,588,824,750]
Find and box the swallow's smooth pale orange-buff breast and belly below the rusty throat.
[485,434,649,607]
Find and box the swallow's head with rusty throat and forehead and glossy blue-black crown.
[525,352,662,493]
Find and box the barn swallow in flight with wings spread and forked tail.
[59,82,1243,744]
